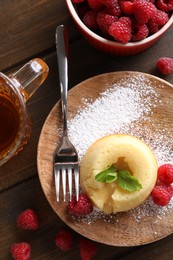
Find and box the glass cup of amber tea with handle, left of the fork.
[0,58,49,166]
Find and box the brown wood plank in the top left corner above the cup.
[0,0,77,70]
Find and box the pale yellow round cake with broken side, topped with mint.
[80,134,158,213]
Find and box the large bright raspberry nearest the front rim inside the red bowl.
[109,17,131,43]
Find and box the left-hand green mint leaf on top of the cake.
[95,165,117,183]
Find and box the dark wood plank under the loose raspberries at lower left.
[0,177,134,260]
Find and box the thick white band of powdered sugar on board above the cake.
[68,76,162,160]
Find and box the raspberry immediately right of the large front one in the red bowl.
[132,24,149,42]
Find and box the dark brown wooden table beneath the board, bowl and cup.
[0,0,173,260]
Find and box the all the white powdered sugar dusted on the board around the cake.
[62,75,173,223]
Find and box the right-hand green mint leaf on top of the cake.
[117,170,142,191]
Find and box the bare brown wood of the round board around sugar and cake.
[37,71,173,246]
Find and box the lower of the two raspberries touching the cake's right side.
[151,184,173,206]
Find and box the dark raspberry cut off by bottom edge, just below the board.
[79,238,98,260]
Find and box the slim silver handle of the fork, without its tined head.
[56,25,68,136]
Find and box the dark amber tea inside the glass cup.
[0,95,20,157]
